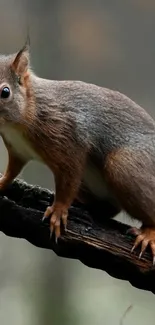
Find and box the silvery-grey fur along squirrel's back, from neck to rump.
[33,76,155,153]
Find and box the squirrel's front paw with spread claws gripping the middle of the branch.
[43,203,68,242]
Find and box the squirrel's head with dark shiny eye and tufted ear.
[0,43,31,125]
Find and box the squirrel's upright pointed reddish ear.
[11,42,29,76]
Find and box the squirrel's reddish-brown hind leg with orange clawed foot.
[104,148,155,263]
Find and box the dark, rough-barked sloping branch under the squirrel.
[0,180,155,293]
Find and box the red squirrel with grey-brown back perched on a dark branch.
[0,44,155,263]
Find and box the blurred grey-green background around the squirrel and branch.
[0,0,155,325]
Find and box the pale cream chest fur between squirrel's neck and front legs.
[0,125,41,162]
